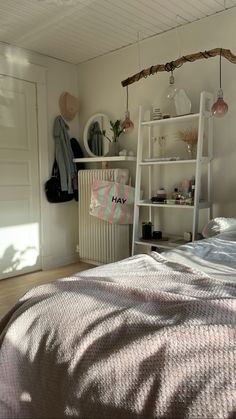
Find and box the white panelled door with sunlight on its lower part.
[0,76,41,279]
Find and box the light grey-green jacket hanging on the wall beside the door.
[53,116,77,193]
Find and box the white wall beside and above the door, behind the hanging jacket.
[0,44,79,269]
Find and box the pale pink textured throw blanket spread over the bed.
[0,253,236,419]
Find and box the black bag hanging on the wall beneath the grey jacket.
[44,159,74,204]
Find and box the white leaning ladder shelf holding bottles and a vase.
[132,92,213,255]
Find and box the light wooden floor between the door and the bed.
[0,262,94,318]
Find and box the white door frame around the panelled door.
[0,56,49,269]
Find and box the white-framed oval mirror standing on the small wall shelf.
[84,113,110,157]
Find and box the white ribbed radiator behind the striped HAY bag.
[78,169,130,265]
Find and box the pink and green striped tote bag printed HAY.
[89,179,135,224]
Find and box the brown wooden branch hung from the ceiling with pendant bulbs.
[121,48,236,87]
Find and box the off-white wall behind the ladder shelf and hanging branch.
[78,9,236,238]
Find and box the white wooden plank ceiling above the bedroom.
[0,0,236,64]
